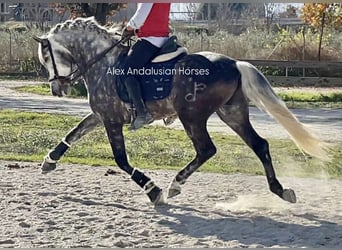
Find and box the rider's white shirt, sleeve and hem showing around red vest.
[127,3,168,48]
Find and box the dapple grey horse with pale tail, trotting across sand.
[36,18,327,204]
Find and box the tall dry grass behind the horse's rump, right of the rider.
[176,29,342,61]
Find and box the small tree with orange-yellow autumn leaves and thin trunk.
[301,3,342,61]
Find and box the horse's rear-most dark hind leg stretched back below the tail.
[217,90,296,203]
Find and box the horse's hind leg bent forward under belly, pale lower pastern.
[167,118,216,198]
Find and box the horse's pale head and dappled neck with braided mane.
[34,18,125,96]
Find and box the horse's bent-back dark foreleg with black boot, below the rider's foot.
[104,121,163,204]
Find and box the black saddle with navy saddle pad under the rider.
[115,36,188,103]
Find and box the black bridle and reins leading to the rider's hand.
[45,35,126,83]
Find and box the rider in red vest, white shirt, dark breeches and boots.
[122,3,171,129]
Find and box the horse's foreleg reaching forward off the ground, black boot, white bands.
[42,113,101,173]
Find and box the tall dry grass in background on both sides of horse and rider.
[0,24,342,72]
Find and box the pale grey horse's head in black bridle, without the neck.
[33,34,77,97]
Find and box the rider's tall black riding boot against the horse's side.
[125,76,153,130]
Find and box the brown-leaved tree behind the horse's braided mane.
[50,3,127,25]
